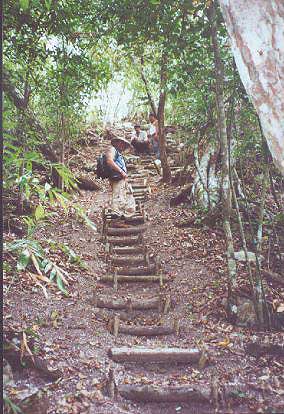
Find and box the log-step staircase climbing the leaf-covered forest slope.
[95,152,210,404]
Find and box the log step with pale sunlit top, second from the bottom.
[108,347,202,364]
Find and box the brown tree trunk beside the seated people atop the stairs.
[158,53,171,182]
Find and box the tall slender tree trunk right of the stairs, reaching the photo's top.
[208,3,237,319]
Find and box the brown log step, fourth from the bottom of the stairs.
[94,296,163,310]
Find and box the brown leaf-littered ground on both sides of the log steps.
[4,137,284,414]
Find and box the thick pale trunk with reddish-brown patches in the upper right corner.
[219,0,284,175]
